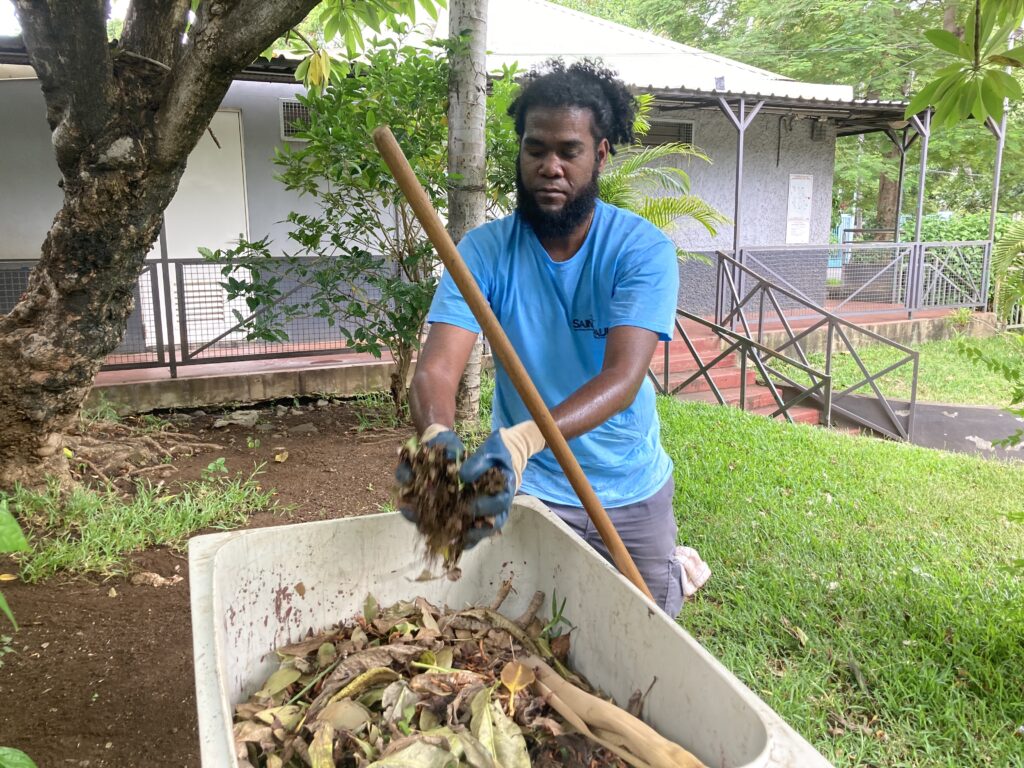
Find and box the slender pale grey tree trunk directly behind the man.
[447,0,487,421]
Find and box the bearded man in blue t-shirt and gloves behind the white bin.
[399,61,704,616]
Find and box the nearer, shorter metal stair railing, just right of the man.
[647,309,831,426]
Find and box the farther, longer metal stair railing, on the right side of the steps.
[716,251,919,440]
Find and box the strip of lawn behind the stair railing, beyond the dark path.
[794,336,1021,407]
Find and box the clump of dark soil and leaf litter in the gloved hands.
[397,440,505,572]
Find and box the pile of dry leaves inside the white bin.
[234,584,698,768]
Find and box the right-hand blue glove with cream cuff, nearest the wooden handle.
[459,421,545,549]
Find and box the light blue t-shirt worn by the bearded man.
[427,202,679,508]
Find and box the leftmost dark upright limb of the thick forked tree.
[15,0,113,171]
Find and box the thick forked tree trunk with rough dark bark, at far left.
[0,0,316,487]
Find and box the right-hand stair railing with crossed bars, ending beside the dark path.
[716,253,918,440]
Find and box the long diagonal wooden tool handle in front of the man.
[373,125,654,601]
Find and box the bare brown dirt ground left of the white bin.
[0,402,412,768]
